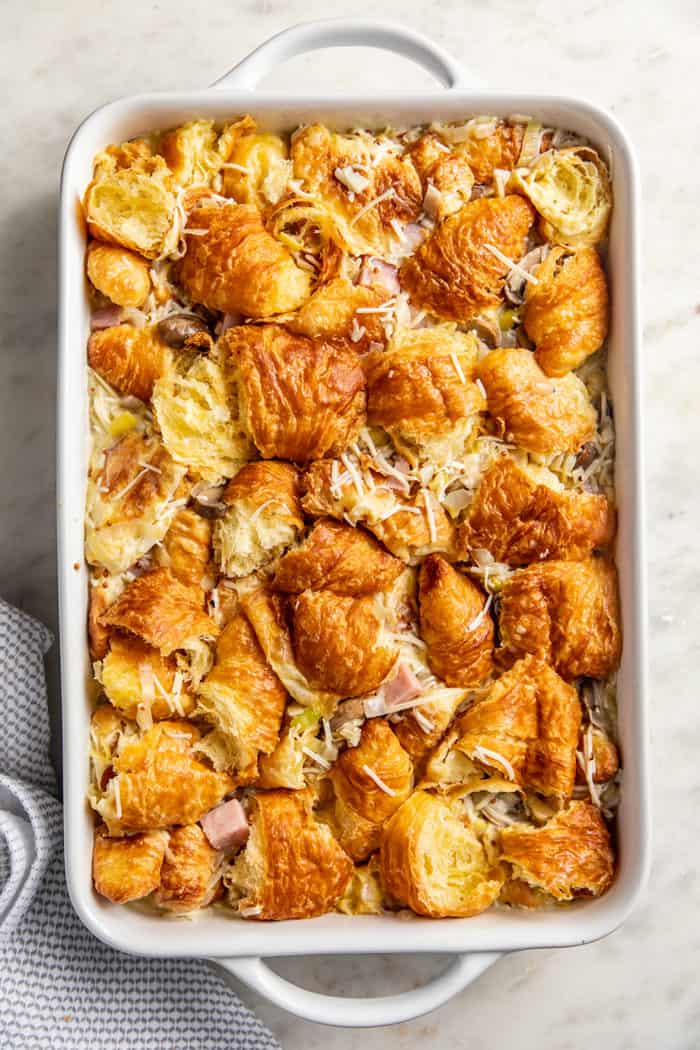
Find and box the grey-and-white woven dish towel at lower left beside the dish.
[0,600,279,1050]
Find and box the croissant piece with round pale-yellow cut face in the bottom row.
[380,791,504,919]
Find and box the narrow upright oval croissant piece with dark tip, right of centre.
[419,554,493,688]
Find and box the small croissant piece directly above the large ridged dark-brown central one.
[284,276,389,352]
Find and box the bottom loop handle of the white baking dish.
[216,952,500,1028]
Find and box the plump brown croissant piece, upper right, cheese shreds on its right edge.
[401,194,534,322]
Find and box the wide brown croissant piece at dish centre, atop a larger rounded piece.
[272,518,404,597]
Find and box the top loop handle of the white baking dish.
[212,18,479,91]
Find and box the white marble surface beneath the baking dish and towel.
[0,0,700,1050]
